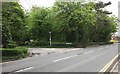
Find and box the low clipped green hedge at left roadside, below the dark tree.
[0,47,28,61]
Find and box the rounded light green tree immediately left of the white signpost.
[27,7,52,42]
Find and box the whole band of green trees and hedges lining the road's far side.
[0,1,118,60]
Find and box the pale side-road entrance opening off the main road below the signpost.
[28,48,83,56]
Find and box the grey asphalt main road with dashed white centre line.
[2,44,118,73]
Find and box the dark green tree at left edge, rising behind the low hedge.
[2,2,25,47]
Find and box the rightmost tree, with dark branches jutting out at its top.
[91,2,117,42]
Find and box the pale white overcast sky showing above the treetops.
[20,0,120,16]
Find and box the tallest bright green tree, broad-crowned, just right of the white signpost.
[54,2,95,47]
